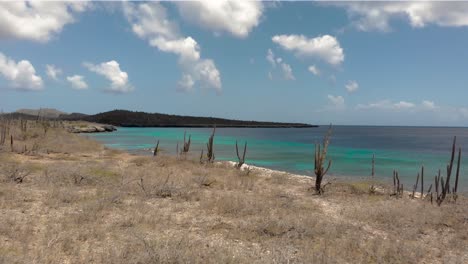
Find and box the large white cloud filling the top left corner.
[0,1,89,42]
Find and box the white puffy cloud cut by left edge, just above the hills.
[0,52,43,91]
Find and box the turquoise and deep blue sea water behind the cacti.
[89,126,468,191]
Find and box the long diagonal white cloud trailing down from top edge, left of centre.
[123,2,222,93]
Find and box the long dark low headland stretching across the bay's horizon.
[60,110,314,127]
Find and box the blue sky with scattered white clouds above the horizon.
[0,0,468,126]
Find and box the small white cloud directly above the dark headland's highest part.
[83,60,134,93]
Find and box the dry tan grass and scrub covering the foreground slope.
[0,118,468,263]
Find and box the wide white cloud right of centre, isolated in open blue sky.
[272,35,344,65]
